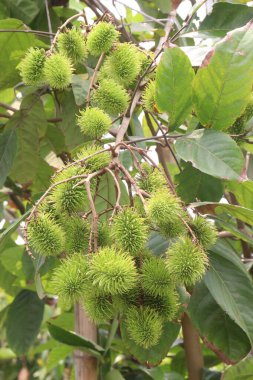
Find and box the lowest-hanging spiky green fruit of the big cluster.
[125,306,163,349]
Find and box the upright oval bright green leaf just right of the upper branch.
[156,47,194,128]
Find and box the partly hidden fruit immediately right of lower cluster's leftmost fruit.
[65,216,90,253]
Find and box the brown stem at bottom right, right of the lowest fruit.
[182,313,204,380]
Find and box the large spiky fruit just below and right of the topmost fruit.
[104,43,141,87]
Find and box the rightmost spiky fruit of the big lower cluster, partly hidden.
[190,216,218,250]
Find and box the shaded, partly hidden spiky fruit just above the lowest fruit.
[142,288,179,321]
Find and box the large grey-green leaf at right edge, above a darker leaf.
[204,245,253,343]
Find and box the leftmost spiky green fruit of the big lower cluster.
[27,213,65,256]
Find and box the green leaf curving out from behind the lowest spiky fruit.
[120,320,180,366]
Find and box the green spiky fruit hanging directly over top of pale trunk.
[82,289,116,325]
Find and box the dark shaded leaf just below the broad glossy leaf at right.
[176,163,223,203]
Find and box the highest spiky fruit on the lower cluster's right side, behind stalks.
[137,162,167,194]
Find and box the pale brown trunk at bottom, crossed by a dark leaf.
[75,304,97,380]
